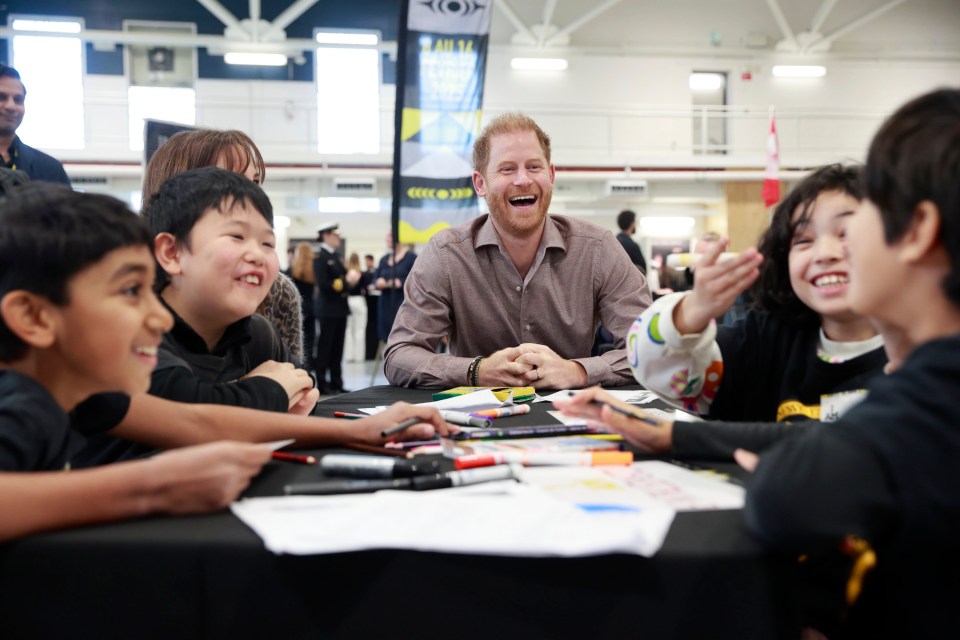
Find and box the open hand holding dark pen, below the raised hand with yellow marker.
[553,387,673,453]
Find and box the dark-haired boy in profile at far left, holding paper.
[0,183,270,540]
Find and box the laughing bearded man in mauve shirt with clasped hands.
[384,113,650,389]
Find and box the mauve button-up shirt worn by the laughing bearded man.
[384,214,650,387]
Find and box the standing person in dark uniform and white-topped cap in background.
[313,222,350,395]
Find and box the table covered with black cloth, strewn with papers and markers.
[0,387,798,639]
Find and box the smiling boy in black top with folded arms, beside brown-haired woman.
[144,167,317,413]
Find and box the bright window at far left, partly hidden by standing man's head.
[10,17,85,149]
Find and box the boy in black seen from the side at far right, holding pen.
[557,89,960,638]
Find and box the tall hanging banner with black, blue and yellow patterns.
[393,0,493,243]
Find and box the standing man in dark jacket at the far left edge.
[0,64,70,186]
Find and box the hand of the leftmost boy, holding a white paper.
[146,442,272,514]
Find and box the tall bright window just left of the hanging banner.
[316,32,380,154]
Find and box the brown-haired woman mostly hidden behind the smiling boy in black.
[140,129,304,363]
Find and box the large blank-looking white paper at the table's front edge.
[231,483,674,556]
